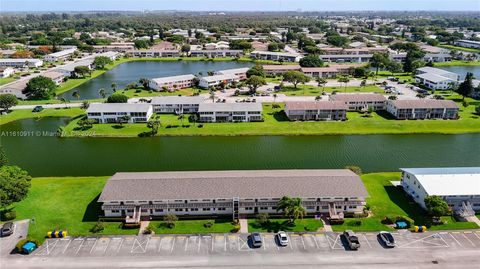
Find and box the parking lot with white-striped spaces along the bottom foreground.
[32,231,480,257]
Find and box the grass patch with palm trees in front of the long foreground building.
[248,218,323,233]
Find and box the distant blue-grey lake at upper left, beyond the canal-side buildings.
[59,61,253,100]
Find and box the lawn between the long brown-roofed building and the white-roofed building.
[332,172,478,231]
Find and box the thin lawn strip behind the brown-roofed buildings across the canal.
[278,85,384,96]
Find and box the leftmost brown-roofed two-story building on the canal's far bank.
[285,101,348,121]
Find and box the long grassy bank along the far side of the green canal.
[64,98,480,137]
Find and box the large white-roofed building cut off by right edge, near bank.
[400,167,480,214]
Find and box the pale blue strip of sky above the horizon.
[0,0,480,12]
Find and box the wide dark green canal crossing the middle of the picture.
[0,118,480,176]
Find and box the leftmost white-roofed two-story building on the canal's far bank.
[87,103,153,123]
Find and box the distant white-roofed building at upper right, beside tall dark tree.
[415,67,460,90]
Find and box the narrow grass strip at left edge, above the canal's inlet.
[0,107,85,125]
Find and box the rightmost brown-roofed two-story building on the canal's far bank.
[386,99,459,120]
